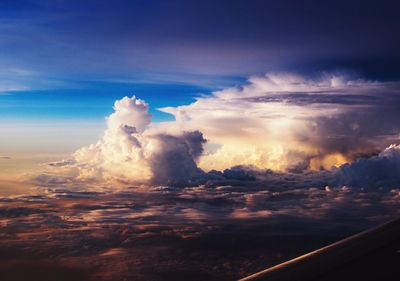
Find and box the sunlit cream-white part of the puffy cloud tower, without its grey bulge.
[74,97,153,180]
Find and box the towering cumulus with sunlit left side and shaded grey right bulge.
[74,97,205,184]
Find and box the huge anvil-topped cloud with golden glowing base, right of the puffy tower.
[161,73,400,171]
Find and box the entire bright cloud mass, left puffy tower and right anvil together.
[43,73,400,187]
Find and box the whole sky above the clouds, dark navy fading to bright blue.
[0,0,400,153]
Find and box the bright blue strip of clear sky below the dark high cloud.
[0,82,225,121]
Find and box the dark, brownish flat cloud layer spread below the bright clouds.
[0,185,400,280]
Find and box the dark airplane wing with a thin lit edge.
[239,219,400,281]
